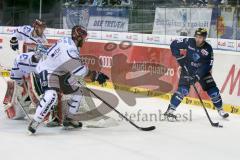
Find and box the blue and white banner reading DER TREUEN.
[63,7,128,32]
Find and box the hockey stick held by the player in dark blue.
[184,66,223,128]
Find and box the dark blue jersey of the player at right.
[170,38,213,78]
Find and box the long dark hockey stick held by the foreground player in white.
[79,83,156,131]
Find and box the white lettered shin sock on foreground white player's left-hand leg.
[34,90,58,123]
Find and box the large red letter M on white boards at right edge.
[221,64,240,96]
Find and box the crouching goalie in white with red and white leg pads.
[3,45,47,120]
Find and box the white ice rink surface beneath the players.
[0,77,240,160]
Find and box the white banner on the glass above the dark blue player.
[153,8,212,36]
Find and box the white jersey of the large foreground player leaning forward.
[36,37,88,76]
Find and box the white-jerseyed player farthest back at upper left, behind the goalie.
[10,19,47,51]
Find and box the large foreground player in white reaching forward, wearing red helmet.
[28,26,108,133]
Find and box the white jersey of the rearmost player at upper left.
[13,25,47,44]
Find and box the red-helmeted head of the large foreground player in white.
[72,25,87,47]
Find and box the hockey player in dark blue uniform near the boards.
[165,28,229,118]
